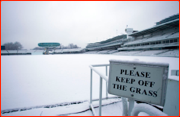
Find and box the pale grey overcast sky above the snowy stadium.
[1,1,179,49]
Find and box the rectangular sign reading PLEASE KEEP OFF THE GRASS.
[108,60,169,106]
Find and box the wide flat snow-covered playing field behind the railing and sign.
[1,54,179,115]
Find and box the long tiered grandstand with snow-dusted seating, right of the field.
[86,14,179,57]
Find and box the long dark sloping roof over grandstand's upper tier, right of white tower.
[129,19,179,36]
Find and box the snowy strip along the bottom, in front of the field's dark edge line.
[3,98,122,116]
